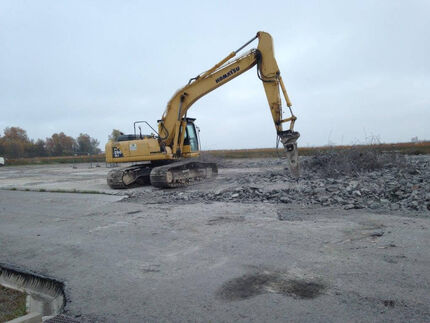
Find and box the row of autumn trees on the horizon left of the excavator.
[0,127,101,158]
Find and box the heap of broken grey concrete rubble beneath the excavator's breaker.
[132,155,430,212]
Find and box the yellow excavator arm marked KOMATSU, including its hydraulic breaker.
[158,32,300,176]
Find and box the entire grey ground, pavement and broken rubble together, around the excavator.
[0,153,430,322]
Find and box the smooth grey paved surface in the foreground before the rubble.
[0,191,430,322]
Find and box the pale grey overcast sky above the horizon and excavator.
[0,0,430,149]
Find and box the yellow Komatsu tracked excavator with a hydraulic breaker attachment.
[106,31,300,189]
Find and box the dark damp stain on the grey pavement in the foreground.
[217,273,326,301]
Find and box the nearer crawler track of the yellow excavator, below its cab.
[150,160,218,188]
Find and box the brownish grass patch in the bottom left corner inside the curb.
[0,286,26,322]
